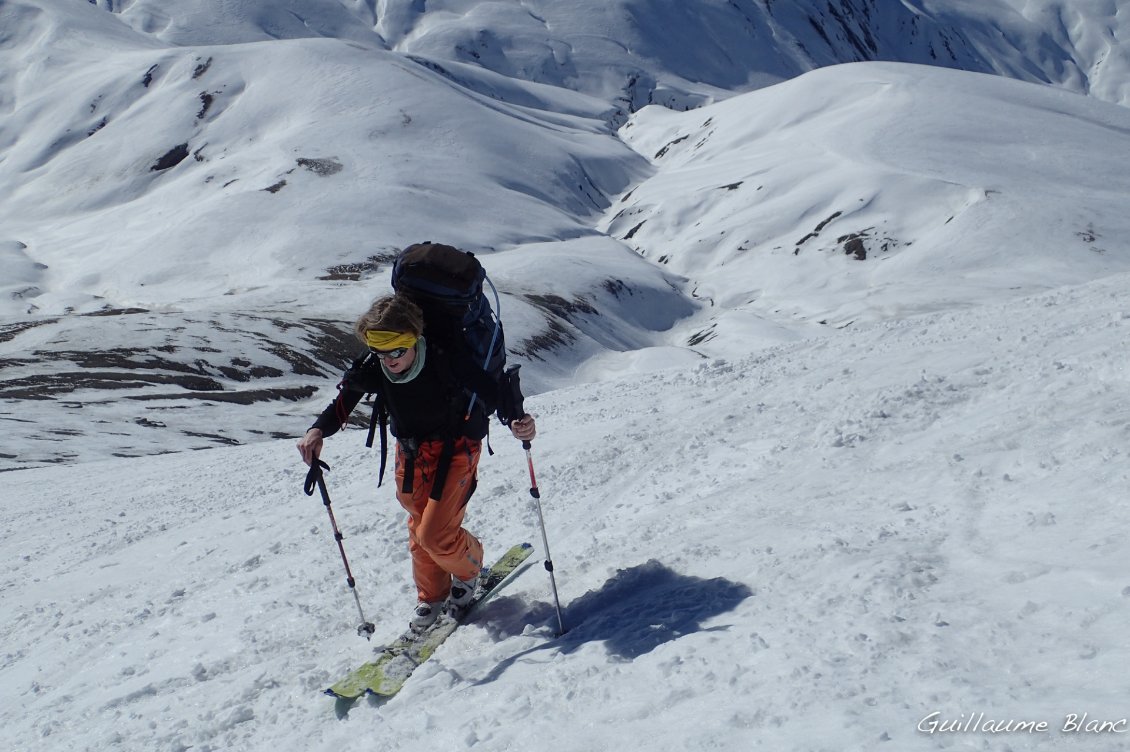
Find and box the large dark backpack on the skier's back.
[392,242,506,415]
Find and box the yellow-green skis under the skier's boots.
[325,543,533,700]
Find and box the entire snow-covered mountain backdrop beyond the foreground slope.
[0,0,1127,468]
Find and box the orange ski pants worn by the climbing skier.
[396,438,483,603]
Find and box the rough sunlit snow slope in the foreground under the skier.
[0,275,1130,752]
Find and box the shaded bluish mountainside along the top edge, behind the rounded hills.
[94,0,1130,118]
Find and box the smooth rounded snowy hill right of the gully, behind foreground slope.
[600,63,1130,353]
